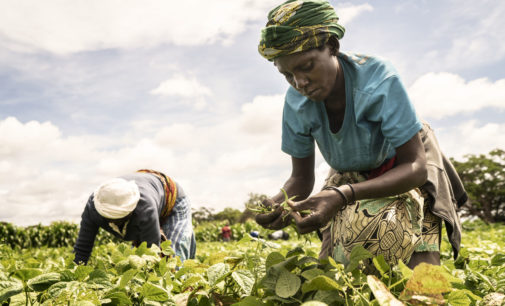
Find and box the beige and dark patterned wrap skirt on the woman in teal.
[320,169,441,264]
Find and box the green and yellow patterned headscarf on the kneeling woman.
[258,0,345,60]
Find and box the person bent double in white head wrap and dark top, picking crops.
[74,170,196,264]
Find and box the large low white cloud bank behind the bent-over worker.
[0,95,310,225]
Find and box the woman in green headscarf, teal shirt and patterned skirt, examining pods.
[256,0,466,267]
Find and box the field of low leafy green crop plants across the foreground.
[0,222,505,306]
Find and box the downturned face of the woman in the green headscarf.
[274,47,338,101]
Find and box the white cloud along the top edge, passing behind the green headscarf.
[0,0,370,54]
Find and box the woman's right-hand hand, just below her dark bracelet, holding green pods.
[288,190,346,234]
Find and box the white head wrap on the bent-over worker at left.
[93,178,140,219]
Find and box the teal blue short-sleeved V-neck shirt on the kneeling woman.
[282,53,422,171]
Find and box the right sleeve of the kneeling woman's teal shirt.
[364,75,422,148]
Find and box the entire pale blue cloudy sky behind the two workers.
[0,0,505,226]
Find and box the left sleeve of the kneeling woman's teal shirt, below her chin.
[281,87,315,158]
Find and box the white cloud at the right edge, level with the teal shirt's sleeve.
[408,72,505,119]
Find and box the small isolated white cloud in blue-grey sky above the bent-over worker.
[150,75,212,110]
